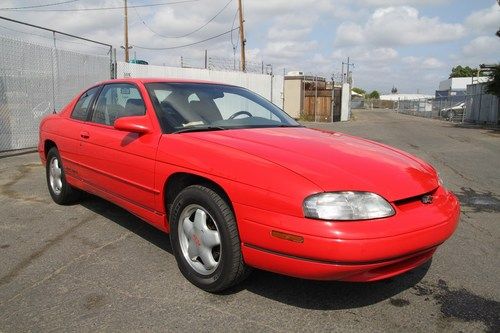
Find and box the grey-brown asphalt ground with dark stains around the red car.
[0,110,500,332]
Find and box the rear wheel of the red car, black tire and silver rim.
[45,147,81,205]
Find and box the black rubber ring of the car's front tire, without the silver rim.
[170,186,239,291]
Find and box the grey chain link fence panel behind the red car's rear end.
[0,20,110,152]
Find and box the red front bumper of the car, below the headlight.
[235,188,460,281]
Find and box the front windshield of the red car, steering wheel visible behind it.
[146,82,300,133]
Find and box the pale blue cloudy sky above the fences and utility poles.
[0,0,500,94]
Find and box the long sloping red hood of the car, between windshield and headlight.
[185,127,438,201]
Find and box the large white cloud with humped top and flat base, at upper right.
[335,6,465,46]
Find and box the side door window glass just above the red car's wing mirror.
[92,83,146,126]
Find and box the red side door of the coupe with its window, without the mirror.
[77,83,161,212]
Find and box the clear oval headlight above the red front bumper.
[304,192,395,221]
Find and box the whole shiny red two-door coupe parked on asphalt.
[38,79,460,292]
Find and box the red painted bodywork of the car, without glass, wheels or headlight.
[39,79,460,281]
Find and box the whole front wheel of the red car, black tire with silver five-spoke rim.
[170,185,250,293]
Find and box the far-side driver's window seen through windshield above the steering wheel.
[215,92,279,121]
